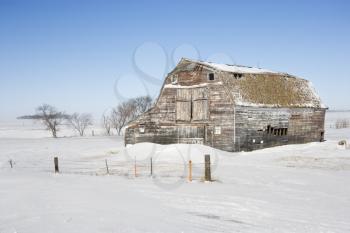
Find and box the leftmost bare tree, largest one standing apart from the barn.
[18,104,69,138]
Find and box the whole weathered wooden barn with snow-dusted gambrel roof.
[125,58,326,151]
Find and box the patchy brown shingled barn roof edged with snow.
[175,58,327,108]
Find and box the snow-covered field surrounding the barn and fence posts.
[0,112,350,233]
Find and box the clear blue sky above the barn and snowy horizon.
[0,0,350,119]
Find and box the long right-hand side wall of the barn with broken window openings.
[236,107,325,150]
